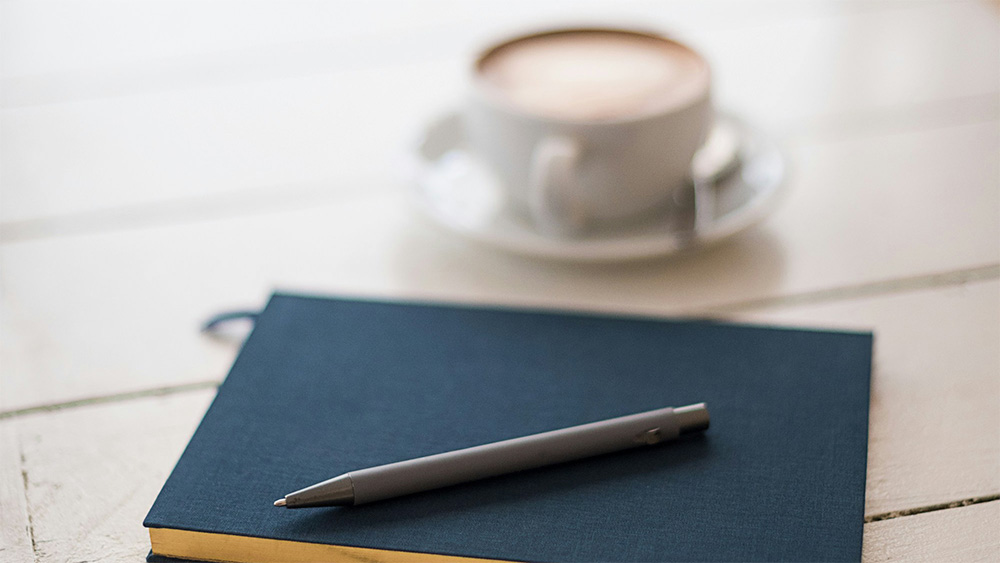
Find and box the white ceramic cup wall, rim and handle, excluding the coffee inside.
[463,28,713,236]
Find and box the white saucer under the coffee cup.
[409,113,784,262]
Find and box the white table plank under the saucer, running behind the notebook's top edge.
[0,118,1000,410]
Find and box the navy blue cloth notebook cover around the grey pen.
[144,294,872,561]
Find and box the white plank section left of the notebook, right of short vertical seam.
[10,390,215,562]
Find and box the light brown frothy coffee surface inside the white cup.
[478,30,709,121]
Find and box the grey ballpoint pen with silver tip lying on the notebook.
[274,403,709,508]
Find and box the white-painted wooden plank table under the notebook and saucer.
[0,0,1000,561]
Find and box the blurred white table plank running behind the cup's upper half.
[0,2,1000,222]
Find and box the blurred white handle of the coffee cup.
[528,137,588,235]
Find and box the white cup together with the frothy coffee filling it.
[463,28,713,236]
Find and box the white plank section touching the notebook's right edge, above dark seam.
[737,280,1000,516]
